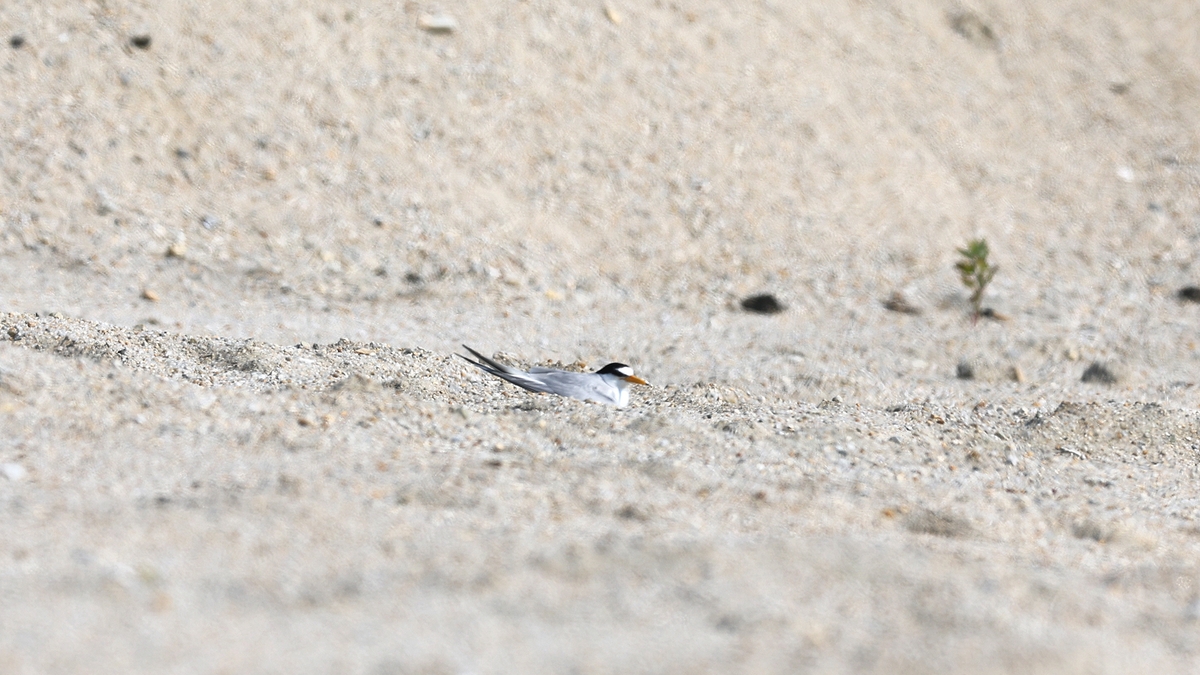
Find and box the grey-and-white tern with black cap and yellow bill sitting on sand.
[457,345,649,407]
